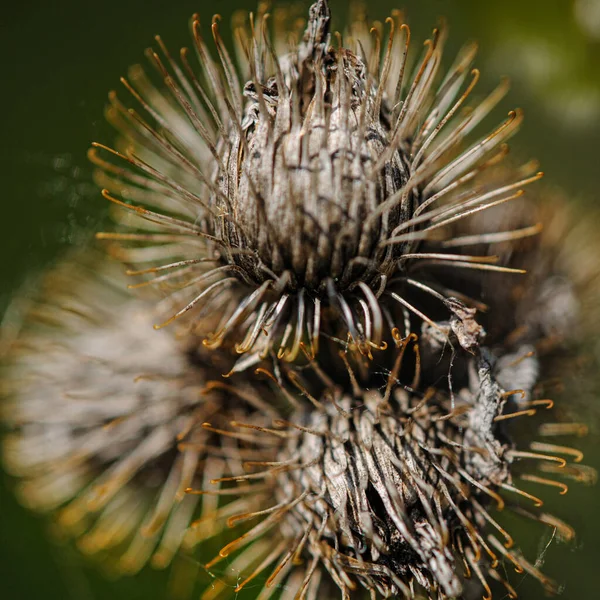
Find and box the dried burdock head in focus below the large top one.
[202,335,595,600]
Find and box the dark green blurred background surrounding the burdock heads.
[0,0,600,600]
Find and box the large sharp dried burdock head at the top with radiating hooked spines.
[90,0,540,366]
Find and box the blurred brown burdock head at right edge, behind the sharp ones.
[436,186,600,358]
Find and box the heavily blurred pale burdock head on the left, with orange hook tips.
[2,256,277,572]
